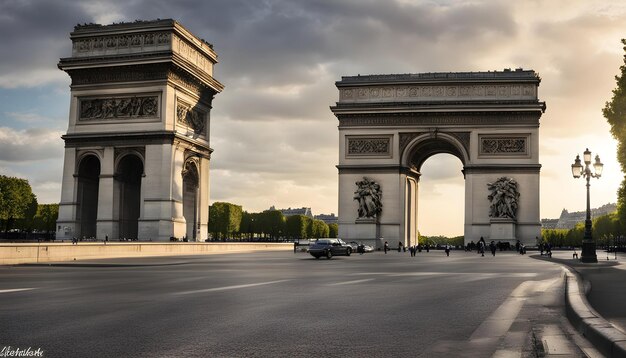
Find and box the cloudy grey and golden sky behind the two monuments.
[0,0,626,235]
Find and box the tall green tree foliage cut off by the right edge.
[602,39,626,228]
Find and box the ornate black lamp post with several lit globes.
[572,148,604,262]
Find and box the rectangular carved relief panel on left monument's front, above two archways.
[78,95,159,121]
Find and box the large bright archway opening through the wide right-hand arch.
[417,153,465,243]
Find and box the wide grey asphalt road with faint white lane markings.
[0,251,576,357]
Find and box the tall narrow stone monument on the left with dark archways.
[57,20,223,241]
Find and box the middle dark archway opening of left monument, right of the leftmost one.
[115,154,143,239]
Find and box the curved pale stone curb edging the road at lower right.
[563,266,626,358]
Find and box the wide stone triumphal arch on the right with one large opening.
[331,69,545,247]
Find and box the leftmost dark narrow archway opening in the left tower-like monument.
[76,155,100,237]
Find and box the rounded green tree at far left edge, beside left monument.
[0,175,37,232]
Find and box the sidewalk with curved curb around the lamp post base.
[531,250,626,357]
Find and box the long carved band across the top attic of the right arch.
[339,84,537,102]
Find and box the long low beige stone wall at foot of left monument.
[0,242,293,265]
